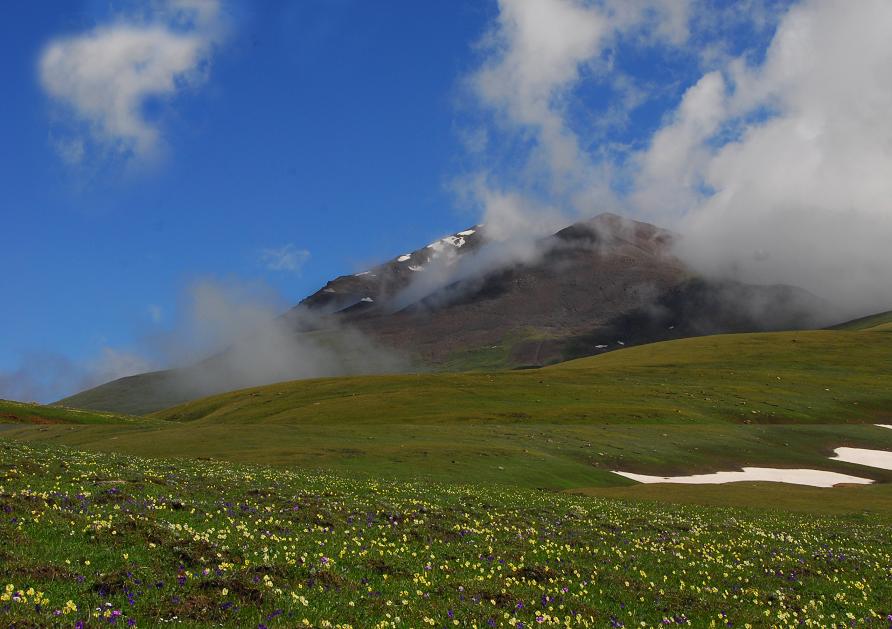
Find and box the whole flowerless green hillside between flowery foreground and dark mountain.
[3,331,892,504]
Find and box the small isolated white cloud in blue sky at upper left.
[38,0,223,163]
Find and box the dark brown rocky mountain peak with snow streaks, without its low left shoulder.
[289,214,817,368]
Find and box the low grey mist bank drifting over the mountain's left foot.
[0,279,411,403]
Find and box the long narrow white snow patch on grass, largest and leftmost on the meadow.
[614,467,873,487]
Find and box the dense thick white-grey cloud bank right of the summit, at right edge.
[634,0,892,311]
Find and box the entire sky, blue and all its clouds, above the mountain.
[0,0,892,398]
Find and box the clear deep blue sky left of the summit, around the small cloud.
[0,1,491,386]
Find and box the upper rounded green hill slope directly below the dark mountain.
[154,331,892,426]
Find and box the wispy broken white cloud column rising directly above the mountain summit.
[469,0,690,232]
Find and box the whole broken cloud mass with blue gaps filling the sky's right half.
[464,0,892,314]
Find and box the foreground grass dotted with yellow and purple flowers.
[0,442,892,629]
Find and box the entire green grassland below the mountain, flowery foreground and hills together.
[0,321,892,629]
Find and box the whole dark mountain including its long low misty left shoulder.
[59,214,824,414]
